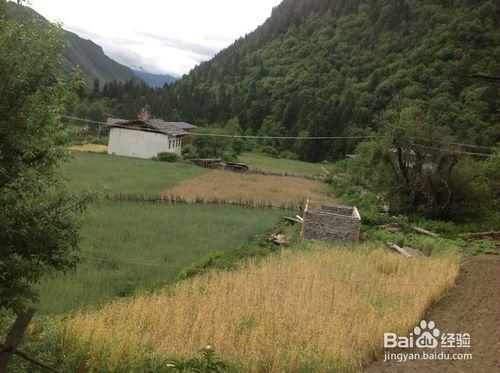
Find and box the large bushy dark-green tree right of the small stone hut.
[347,103,494,219]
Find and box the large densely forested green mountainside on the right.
[166,0,500,160]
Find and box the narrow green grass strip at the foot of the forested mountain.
[239,153,325,176]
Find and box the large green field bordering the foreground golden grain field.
[37,201,284,314]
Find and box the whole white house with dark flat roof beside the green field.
[108,118,189,159]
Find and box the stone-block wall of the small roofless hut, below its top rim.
[303,210,361,242]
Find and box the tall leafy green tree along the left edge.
[0,4,85,311]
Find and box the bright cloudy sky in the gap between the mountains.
[30,0,281,76]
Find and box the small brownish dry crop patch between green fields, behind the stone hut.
[166,171,329,206]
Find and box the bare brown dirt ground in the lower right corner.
[364,255,500,373]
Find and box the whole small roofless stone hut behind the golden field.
[302,201,361,242]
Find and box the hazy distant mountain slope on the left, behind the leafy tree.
[6,2,141,86]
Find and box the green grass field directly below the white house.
[61,152,206,195]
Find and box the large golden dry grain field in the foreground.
[56,246,458,372]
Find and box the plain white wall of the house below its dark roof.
[108,128,182,159]
